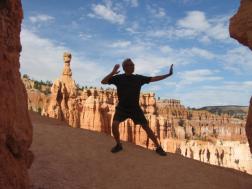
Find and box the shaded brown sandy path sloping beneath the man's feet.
[29,113,252,189]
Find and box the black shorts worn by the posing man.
[113,106,148,126]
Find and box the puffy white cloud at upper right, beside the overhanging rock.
[146,11,229,43]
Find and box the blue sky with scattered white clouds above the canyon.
[20,0,252,108]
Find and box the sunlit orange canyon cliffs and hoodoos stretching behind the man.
[23,52,252,174]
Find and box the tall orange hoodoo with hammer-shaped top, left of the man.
[42,52,80,127]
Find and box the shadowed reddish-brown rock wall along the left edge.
[0,0,33,189]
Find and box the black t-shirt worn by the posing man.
[108,74,151,108]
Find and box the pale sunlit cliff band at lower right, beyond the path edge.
[164,139,252,174]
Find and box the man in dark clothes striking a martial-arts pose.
[101,58,173,156]
